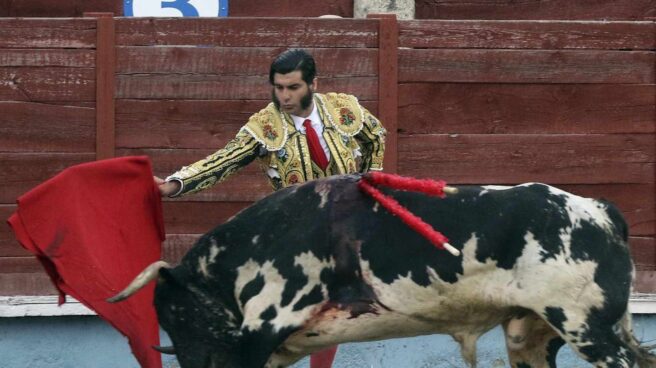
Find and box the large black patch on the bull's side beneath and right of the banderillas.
[351,184,571,286]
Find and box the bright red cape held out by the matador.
[8,157,164,368]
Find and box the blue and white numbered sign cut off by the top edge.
[123,0,228,17]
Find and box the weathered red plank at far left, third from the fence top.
[0,67,96,101]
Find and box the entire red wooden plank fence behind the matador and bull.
[0,16,656,295]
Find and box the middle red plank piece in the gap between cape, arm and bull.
[163,201,251,234]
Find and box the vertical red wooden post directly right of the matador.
[368,14,399,173]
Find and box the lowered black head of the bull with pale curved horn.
[108,261,241,368]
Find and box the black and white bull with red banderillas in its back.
[111,175,656,368]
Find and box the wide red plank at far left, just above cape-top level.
[0,101,95,152]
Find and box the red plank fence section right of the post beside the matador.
[398,18,656,291]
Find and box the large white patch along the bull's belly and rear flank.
[285,232,604,355]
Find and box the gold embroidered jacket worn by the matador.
[166,93,386,196]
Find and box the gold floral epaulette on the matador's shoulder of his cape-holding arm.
[241,102,287,151]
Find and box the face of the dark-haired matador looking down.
[273,70,317,117]
